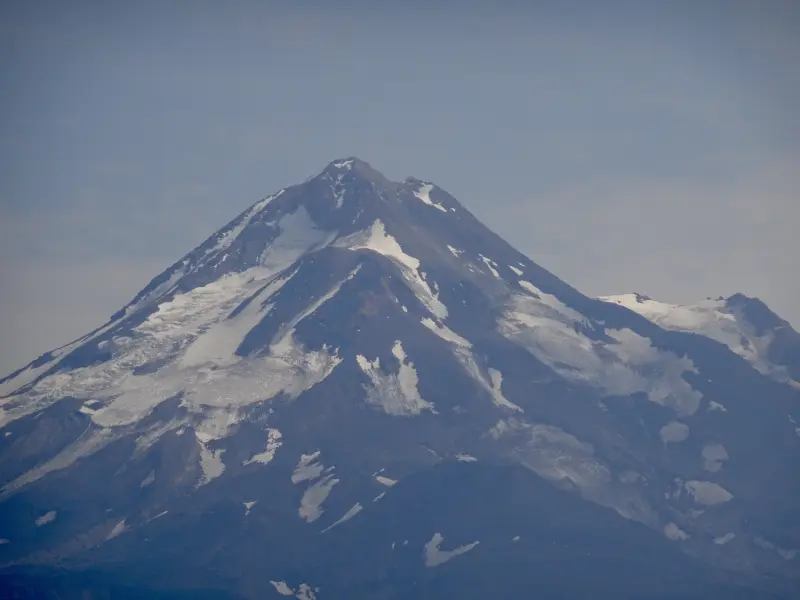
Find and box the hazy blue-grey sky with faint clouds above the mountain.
[0,0,800,375]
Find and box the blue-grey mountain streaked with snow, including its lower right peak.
[0,158,800,600]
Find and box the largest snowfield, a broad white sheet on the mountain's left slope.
[0,208,340,452]
